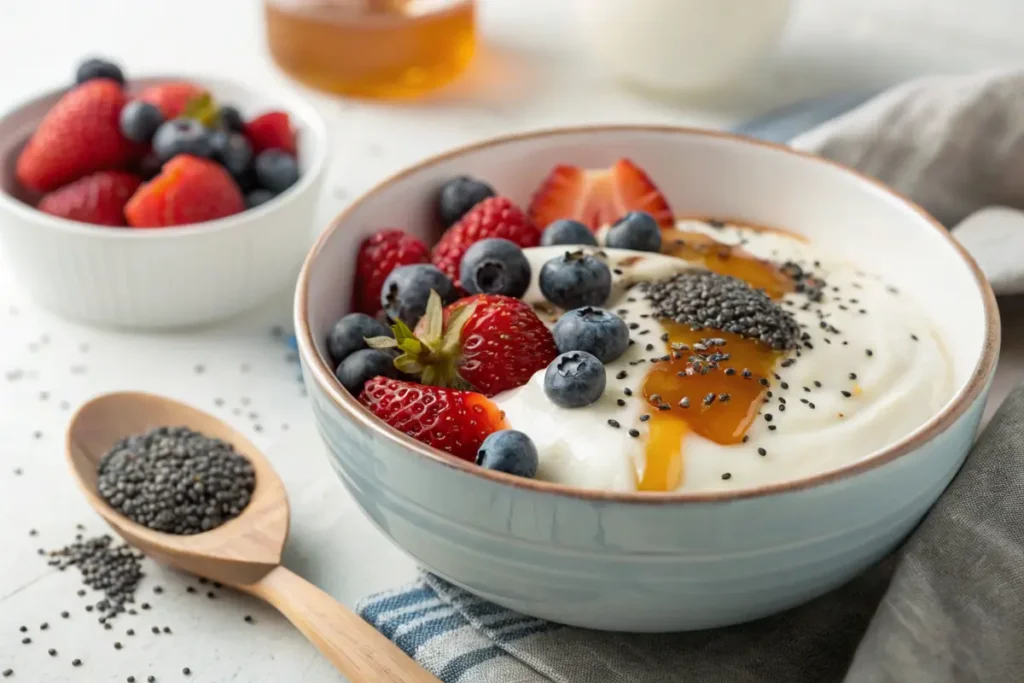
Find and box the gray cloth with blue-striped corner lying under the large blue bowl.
[358,387,1024,683]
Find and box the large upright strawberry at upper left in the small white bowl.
[16,79,139,193]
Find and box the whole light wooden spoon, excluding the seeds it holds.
[68,392,439,683]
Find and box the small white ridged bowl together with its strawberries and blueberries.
[0,60,327,329]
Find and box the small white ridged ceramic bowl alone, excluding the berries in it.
[0,75,328,329]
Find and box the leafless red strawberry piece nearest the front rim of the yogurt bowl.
[359,377,505,462]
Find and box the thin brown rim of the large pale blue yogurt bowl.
[294,124,1000,505]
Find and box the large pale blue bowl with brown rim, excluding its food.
[295,127,999,631]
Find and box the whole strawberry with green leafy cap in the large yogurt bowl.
[368,292,558,396]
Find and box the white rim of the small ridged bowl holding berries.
[0,73,329,241]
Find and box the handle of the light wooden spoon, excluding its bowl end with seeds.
[245,566,440,683]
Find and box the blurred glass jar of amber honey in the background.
[264,0,476,98]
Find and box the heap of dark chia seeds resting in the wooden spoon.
[97,427,256,536]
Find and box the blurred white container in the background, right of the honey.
[575,0,792,91]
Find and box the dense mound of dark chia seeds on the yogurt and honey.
[643,270,801,351]
